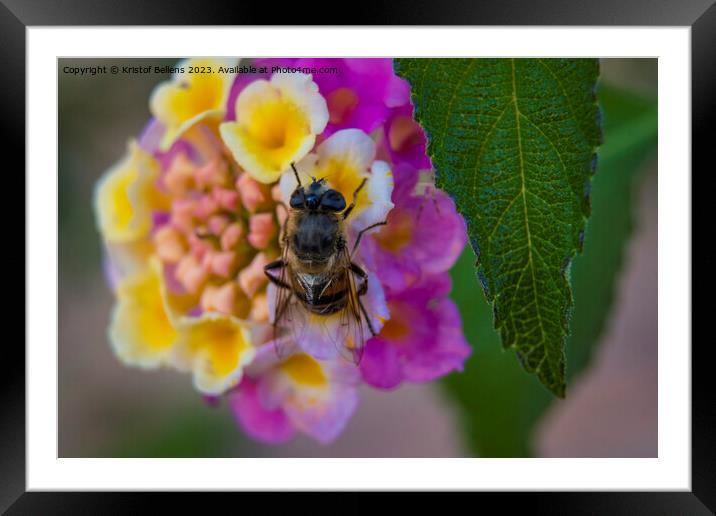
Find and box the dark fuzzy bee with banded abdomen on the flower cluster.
[264,163,387,363]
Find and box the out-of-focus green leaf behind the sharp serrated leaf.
[444,85,657,457]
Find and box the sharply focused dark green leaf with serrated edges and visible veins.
[396,59,600,397]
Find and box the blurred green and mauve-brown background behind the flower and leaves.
[58,59,658,457]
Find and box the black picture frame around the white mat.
[5,0,716,515]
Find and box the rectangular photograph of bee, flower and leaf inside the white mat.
[58,56,659,458]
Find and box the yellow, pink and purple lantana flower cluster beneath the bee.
[95,58,470,443]
